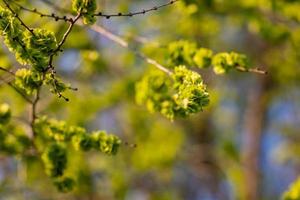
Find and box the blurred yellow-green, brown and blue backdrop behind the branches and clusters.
[0,0,300,200]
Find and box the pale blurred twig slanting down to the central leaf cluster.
[91,25,172,75]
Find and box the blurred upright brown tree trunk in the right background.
[242,78,268,200]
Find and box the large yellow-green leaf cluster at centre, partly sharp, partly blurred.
[136,66,209,120]
